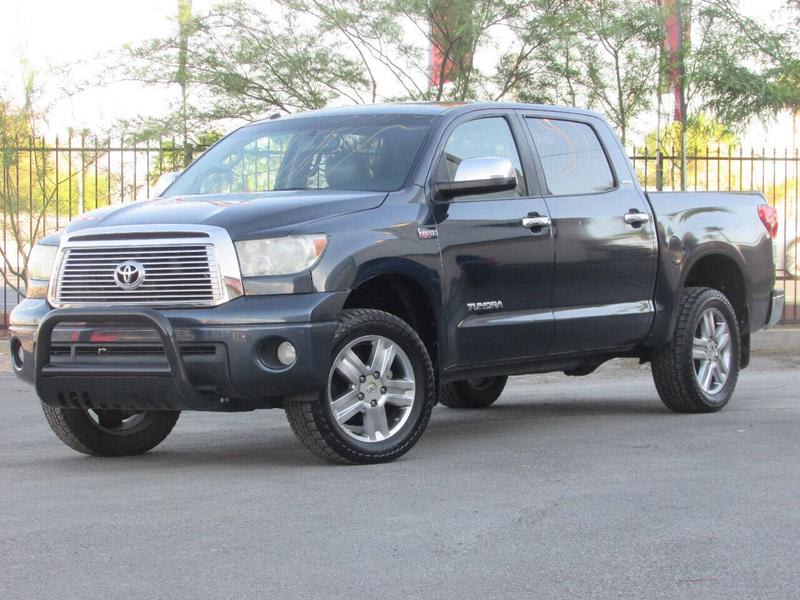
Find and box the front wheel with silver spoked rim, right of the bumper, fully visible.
[286,309,436,464]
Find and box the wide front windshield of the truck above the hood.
[164,114,435,197]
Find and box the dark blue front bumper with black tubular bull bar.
[10,293,345,411]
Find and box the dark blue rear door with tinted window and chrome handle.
[523,112,657,355]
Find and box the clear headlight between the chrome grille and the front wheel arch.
[236,235,328,277]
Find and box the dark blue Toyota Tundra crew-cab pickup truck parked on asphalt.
[10,103,783,464]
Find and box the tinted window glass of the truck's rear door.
[525,118,614,196]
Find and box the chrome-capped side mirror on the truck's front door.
[436,156,517,199]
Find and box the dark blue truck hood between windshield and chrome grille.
[67,190,387,240]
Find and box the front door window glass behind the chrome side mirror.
[436,117,527,198]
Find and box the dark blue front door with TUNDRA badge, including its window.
[431,113,553,369]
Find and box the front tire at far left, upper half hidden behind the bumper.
[42,404,181,456]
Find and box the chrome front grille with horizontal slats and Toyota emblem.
[53,240,225,306]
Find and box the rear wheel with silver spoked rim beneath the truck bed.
[652,287,742,413]
